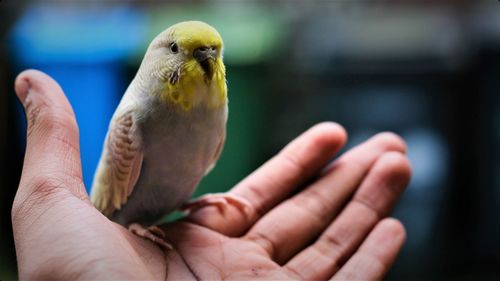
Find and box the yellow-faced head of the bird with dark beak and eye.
[141,21,227,109]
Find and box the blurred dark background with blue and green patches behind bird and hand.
[0,0,500,280]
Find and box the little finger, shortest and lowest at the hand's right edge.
[333,219,406,280]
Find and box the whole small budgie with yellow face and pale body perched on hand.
[91,21,248,247]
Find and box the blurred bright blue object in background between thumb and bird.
[9,5,146,192]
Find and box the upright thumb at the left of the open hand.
[13,70,86,217]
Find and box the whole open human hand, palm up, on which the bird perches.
[12,70,410,280]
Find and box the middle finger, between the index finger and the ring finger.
[245,134,405,264]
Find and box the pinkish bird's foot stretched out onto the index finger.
[180,193,252,216]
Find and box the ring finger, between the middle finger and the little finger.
[286,152,410,280]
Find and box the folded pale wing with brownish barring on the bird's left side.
[91,107,143,217]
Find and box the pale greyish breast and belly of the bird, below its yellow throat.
[113,99,227,223]
